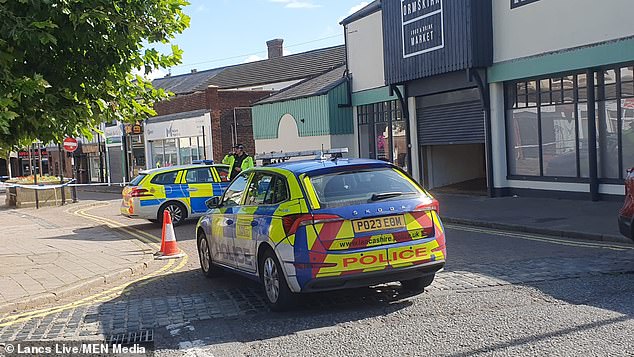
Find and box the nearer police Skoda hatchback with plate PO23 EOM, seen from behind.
[196,159,446,310]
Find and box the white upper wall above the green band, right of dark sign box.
[493,0,634,63]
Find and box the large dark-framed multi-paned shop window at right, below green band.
[505,65,634,182]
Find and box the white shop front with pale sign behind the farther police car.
[145,110,213,168]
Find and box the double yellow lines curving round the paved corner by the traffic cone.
[0,204,189,328]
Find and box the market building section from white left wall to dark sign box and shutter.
[342,0,492,191]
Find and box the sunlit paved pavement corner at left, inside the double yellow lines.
[0,192,153,311]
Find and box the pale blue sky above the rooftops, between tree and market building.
[150,0,371,78]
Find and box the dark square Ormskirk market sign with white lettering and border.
[401,0,445,58]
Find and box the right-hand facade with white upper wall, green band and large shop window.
[488,0,634,200]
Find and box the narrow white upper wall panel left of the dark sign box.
[345,11,385,92]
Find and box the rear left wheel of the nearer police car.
[260,249,296,311]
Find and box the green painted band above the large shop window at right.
[488,38,634,83]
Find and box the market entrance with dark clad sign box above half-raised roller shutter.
[378,0,492,192]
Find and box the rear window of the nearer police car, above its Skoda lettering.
[310,168,422,207]
